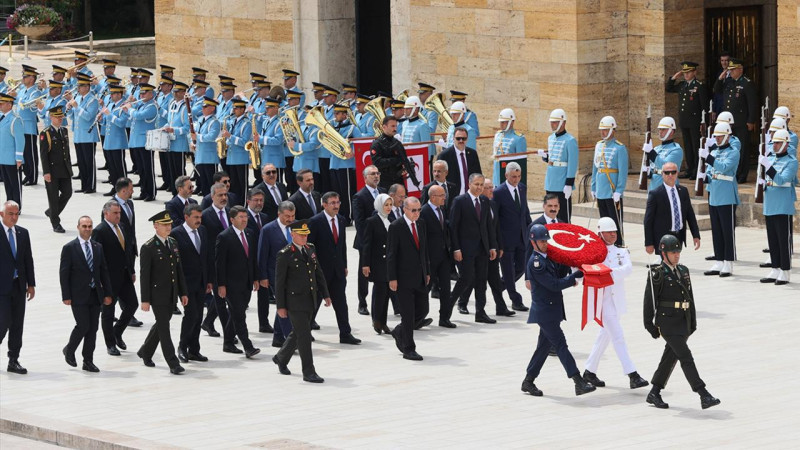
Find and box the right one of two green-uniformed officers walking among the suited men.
[272,220,331,383]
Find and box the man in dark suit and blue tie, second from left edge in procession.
[58,216,112,372]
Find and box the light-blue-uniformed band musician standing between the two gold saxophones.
[221,98,253,206]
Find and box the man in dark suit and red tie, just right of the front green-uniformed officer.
[308,191,361,345]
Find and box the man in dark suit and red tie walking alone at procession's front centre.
[386,197,431,361]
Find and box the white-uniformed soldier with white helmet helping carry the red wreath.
[583,217,649,389]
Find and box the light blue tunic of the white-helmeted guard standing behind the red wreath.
[592,139,628,200]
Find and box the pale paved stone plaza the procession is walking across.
[0,161,800,449]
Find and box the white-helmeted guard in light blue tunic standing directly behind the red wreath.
[592,116,628,245]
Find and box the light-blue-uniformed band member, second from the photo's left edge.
[16,64,45,186]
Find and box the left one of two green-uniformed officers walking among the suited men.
[136,210,189,375]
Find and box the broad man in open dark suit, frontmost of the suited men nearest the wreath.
[450,173,497,323]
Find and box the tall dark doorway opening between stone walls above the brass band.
[356,0,392,95]
